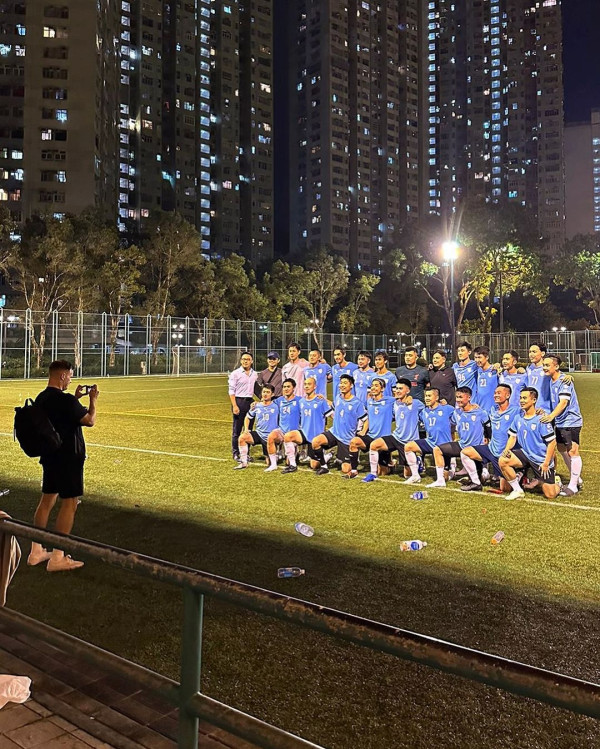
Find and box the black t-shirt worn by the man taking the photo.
[35,387,87,463]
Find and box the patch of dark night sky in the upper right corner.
[562,0,600,122]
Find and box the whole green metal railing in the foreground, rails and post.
[0,519,600,749]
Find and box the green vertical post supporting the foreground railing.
[177,588,204,749]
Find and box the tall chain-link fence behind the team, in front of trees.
[0,309,600,378]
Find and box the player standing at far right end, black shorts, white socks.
[541,355,583,497]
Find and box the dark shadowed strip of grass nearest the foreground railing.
[3,486,600,749]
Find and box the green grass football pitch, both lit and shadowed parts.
[0,374,600,749]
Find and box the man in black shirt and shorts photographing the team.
[27,360,98,572]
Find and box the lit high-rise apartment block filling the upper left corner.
[0,0,273,263]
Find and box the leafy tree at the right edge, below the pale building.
[554,234,600,325]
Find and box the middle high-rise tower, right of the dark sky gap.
[290,0,419,271]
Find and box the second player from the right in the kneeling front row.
[460,385,521,492]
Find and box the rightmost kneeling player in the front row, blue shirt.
[499,387,560,499]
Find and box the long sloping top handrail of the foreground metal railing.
[0,519,600,747]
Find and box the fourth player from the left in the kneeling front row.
[312,375,369,476]
